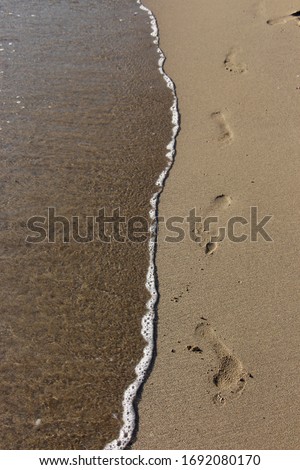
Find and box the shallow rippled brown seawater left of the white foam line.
[0,0,173,449]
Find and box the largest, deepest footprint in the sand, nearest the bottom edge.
[194,322,249,404]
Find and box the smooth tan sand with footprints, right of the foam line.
[134,0,300,449]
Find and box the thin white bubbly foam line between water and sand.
[105,0,179,450]
